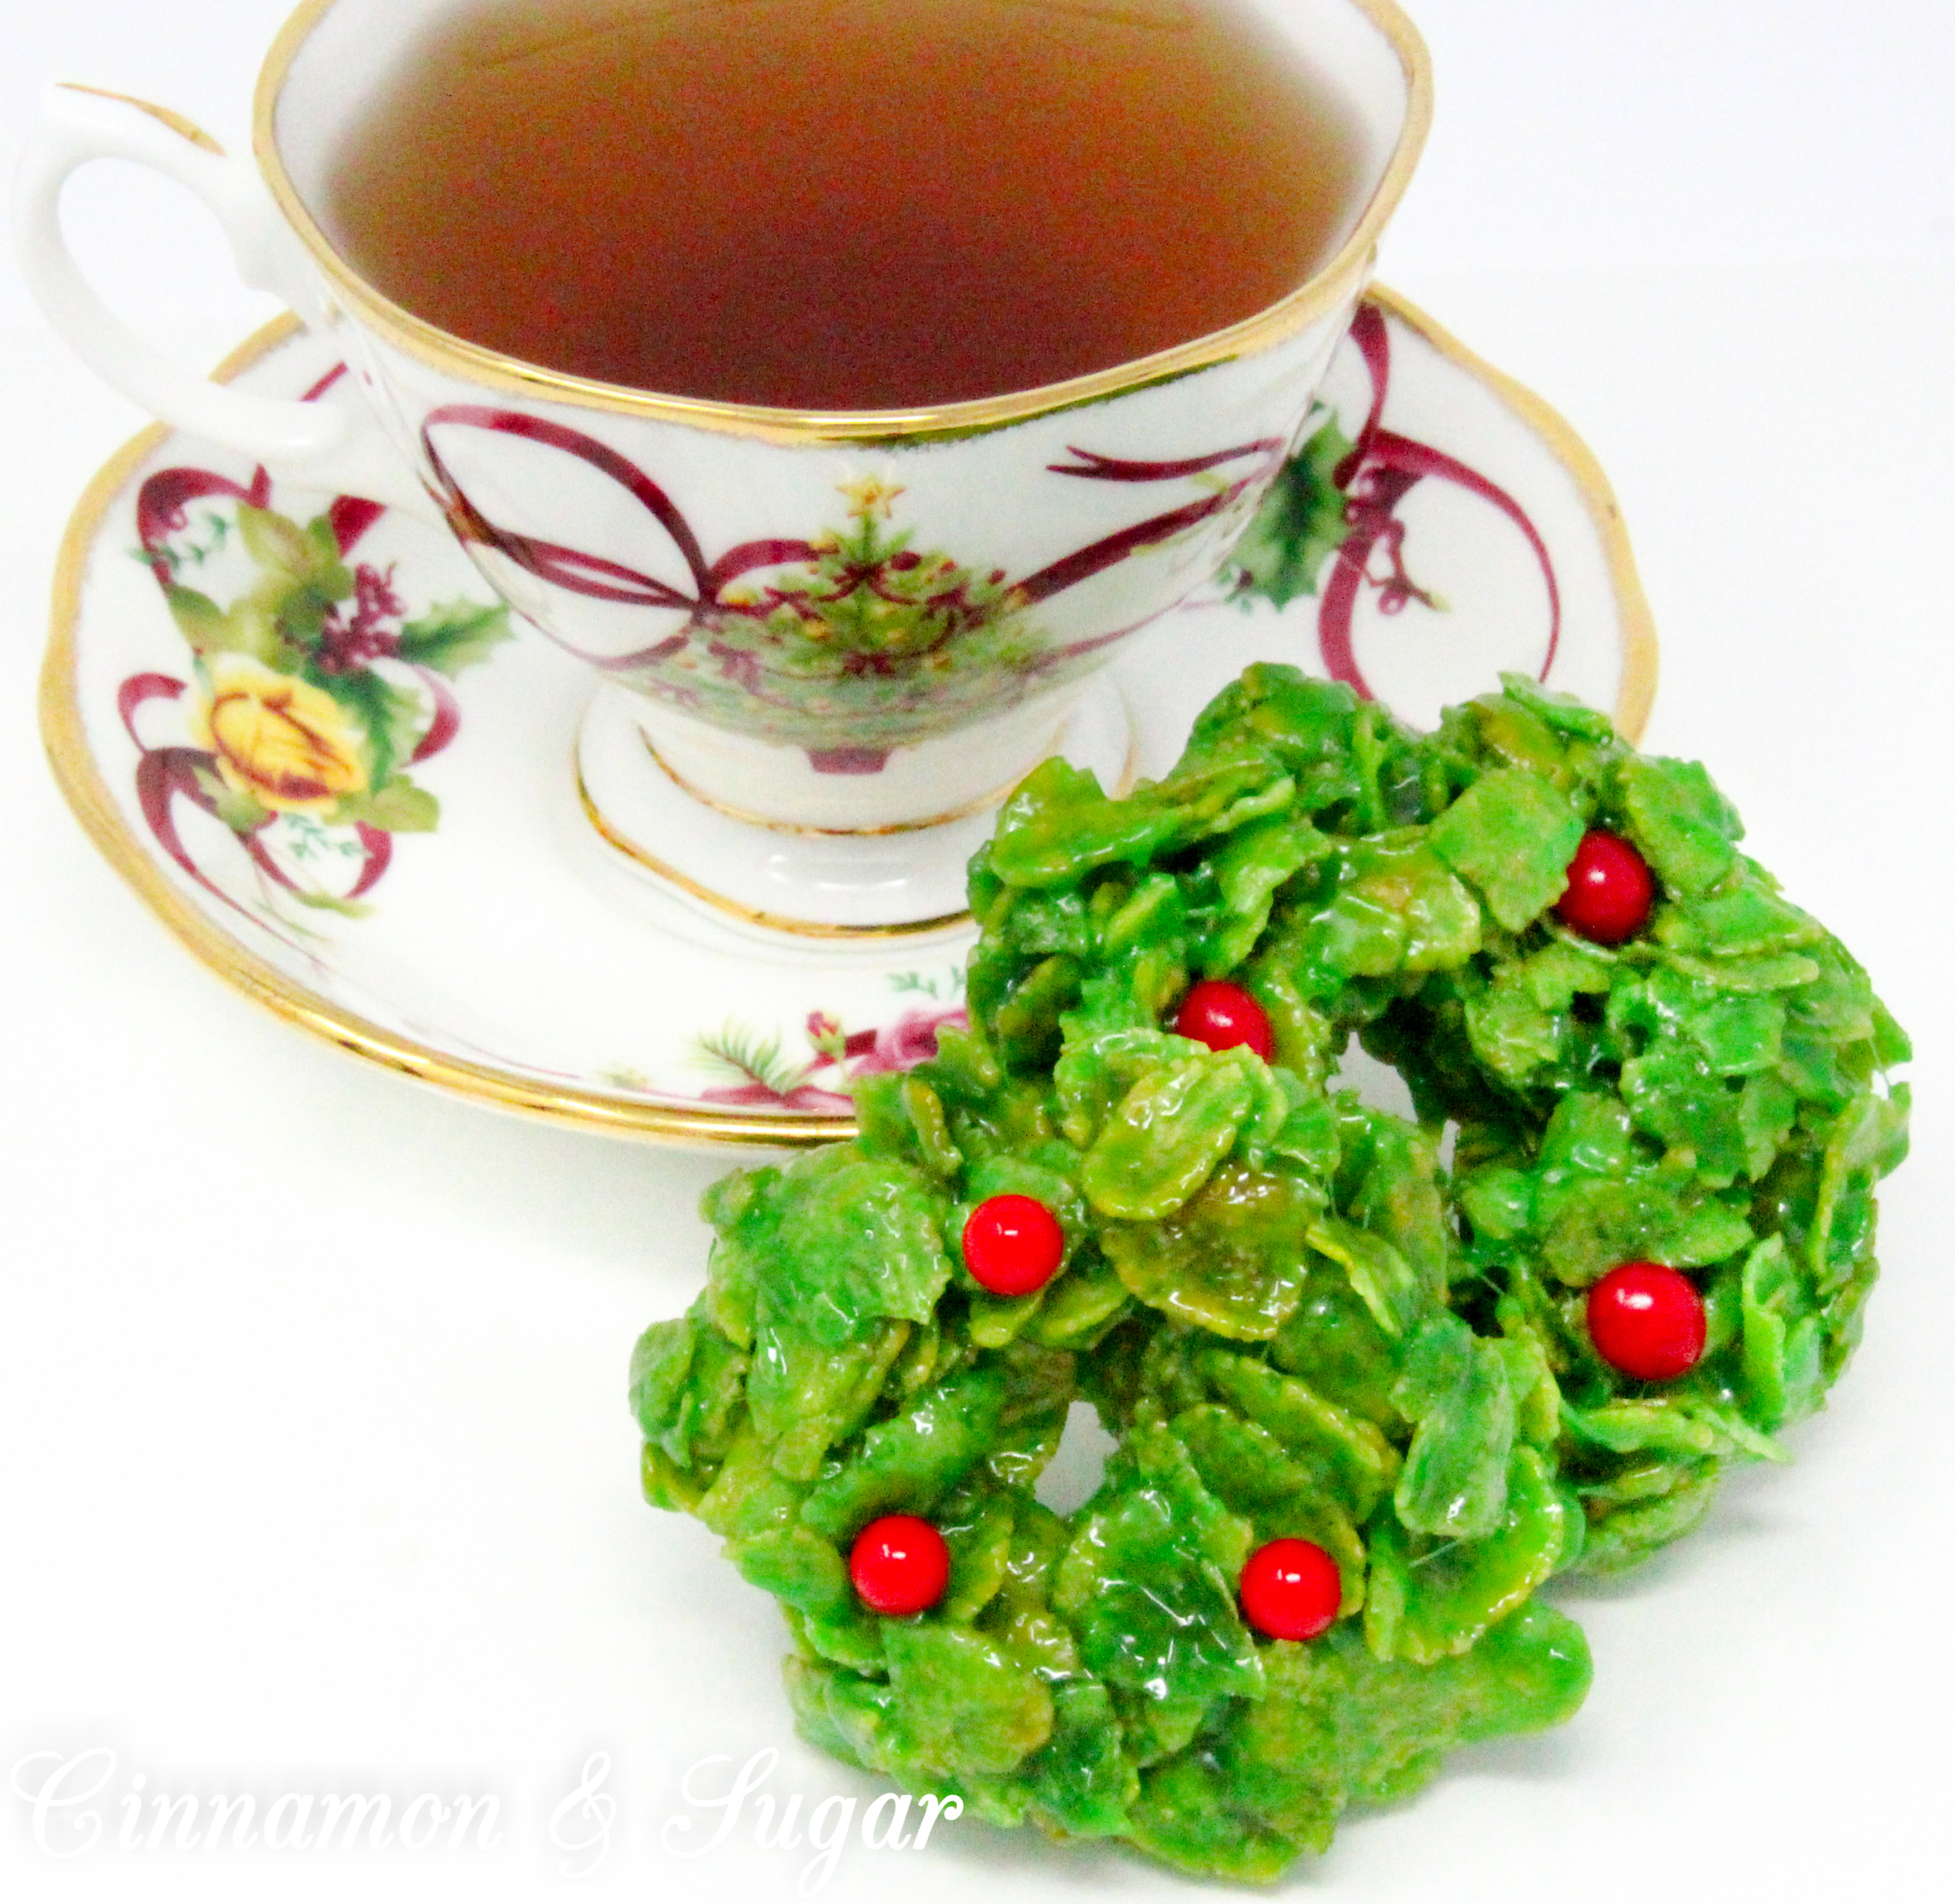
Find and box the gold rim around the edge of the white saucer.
[41,286,1656,1147]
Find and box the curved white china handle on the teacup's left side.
[14,86,440,520]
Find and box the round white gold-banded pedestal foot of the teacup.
[577,674,1132,939]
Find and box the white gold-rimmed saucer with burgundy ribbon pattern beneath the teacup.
[41,291,1656,1143]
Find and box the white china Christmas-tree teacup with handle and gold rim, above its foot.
[15,0,1431,832]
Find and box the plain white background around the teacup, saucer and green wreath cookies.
[0,0,1955,1904]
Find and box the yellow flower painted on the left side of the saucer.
[189,655,367,813]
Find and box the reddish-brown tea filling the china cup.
[317,0,1359,411]
